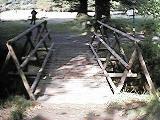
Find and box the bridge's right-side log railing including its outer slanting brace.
[89,21,156,95]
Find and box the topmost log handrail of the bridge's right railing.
[97,21,140,42]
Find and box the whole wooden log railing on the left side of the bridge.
[1,21,54,100]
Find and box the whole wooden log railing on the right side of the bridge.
[90,21,155,94]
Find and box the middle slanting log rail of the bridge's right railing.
[94,32,129,69]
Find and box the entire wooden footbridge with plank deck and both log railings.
[1,21,155,103]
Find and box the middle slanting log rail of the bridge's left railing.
[20,32,49,68]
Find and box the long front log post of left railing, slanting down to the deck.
[7,43,35,100]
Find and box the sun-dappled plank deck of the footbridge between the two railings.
[35,34,112,104]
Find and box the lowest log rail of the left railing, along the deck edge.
[31,43,54,93]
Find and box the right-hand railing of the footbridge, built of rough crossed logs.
[90,21,156,95]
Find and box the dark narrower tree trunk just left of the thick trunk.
[78,0,88,14]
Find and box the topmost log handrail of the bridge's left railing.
[8,21,47,44]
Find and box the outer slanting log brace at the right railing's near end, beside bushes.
[136,45,156,95]
